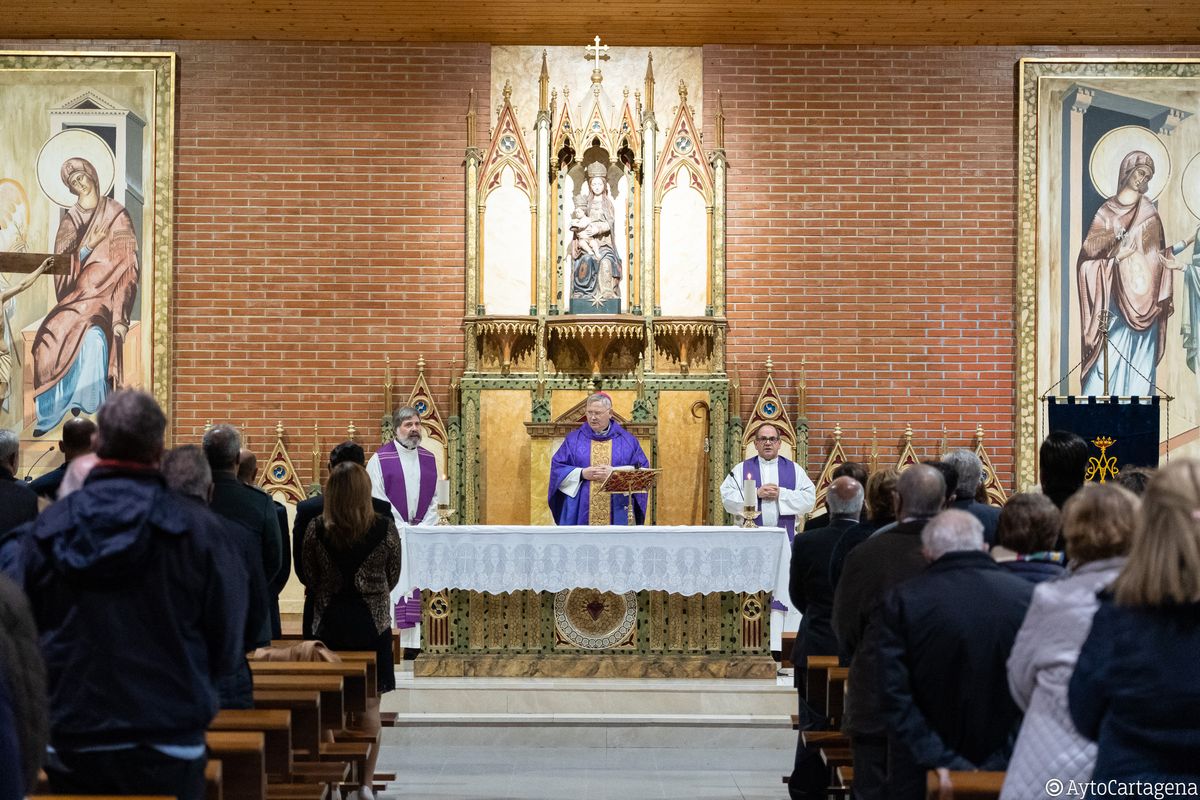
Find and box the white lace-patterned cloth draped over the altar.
[404,525,791,603]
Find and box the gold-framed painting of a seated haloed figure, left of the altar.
[0,53,175,471]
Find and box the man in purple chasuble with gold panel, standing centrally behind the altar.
[550,392,650,525]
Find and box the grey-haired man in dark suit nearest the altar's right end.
[787,475,863,800]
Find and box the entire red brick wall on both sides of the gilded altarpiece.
[2,42,1200,491]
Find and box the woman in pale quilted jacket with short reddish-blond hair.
[1000,483,1138,800]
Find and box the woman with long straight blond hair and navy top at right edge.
[1069,459,1200,796]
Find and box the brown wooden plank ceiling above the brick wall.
[7,0,1200,46]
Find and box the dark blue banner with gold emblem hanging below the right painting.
[1048,397,1159,482]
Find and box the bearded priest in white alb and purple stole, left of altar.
[367,405,438,649]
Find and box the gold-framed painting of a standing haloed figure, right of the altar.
[1016,59,1200,487]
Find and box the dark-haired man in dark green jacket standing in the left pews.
[204,425,283,639]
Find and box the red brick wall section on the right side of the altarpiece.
[700,46,1198,489]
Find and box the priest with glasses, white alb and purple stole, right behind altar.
[721,423,817,541]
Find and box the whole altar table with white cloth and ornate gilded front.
[406,528,787,678]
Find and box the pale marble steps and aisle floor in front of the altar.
[378,672,796,800]
